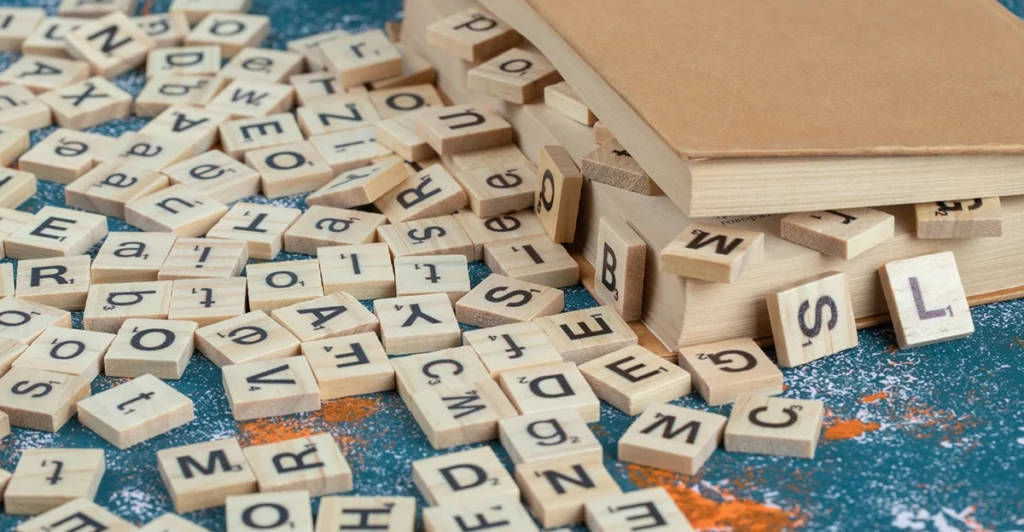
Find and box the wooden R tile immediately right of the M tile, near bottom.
[243,433,352,497]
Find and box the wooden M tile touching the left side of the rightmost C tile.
[618,404,726,475]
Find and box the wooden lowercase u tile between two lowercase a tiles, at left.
[125,184,227,236]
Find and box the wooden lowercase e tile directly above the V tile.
[196,310,299,367]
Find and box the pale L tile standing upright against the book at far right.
[879,252,974,349]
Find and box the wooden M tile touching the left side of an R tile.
[157,438,256,514]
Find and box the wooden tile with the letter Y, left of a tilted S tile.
[374,294,461,355]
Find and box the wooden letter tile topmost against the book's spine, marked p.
[427,7,522,62]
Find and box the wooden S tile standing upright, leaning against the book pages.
[765,271,857,367]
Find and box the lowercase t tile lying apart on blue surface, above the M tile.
[78,374,196,449]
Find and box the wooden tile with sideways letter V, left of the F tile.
[222,356,321,422]
